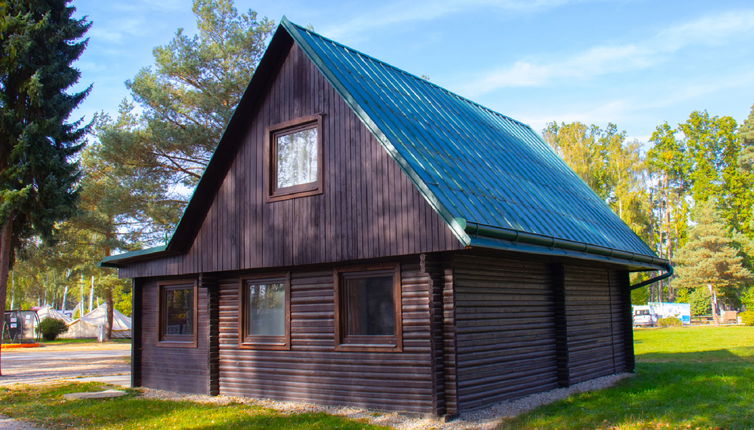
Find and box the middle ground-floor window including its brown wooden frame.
[240,276,290,349]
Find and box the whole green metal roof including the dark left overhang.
[100,17,656,268]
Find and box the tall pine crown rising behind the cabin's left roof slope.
[97,0,274,242]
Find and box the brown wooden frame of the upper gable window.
[264,114,324,203]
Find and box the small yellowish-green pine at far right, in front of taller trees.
[674,201,752,322]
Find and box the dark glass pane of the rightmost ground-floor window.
[342,275,395,336]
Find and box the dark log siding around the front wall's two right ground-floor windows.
[214,258,433,413]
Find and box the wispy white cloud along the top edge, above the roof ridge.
[322,0,585,39]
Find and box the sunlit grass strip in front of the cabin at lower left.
[0,383,384,430]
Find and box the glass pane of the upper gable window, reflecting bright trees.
[277,128,318,188]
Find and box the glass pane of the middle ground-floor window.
[246,283,285,336]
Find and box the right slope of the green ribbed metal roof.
[281,18,657,260]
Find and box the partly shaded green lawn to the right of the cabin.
[501,327,754,429]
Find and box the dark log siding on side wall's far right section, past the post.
[565,266,626,384]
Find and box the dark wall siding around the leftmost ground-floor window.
[141,280,209,394]
